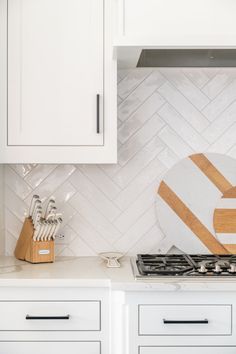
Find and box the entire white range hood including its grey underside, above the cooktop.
[114,0,236,68]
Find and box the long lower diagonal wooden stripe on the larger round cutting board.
[158,181,230,254]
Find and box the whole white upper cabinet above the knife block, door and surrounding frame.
[0,0,116,163]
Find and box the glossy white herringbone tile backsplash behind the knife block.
[0,68,236,256]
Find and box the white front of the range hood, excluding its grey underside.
[117,0,236,47]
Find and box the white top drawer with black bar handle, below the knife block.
[0,301,101,331]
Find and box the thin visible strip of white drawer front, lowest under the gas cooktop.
[139,347,236,354]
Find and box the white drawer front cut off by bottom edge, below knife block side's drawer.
[0,342,101,354]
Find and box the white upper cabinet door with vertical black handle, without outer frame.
[7,0,104,147]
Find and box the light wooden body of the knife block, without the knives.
[14,218,55,263]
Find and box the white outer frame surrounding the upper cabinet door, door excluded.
[0,0,117,164]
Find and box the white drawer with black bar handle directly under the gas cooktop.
[139,305,232,336]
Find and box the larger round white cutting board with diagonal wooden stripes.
[156,153,236,254]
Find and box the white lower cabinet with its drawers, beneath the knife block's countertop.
[0,287,110,354]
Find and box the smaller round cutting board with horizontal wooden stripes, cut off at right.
[213,187,236,254]
